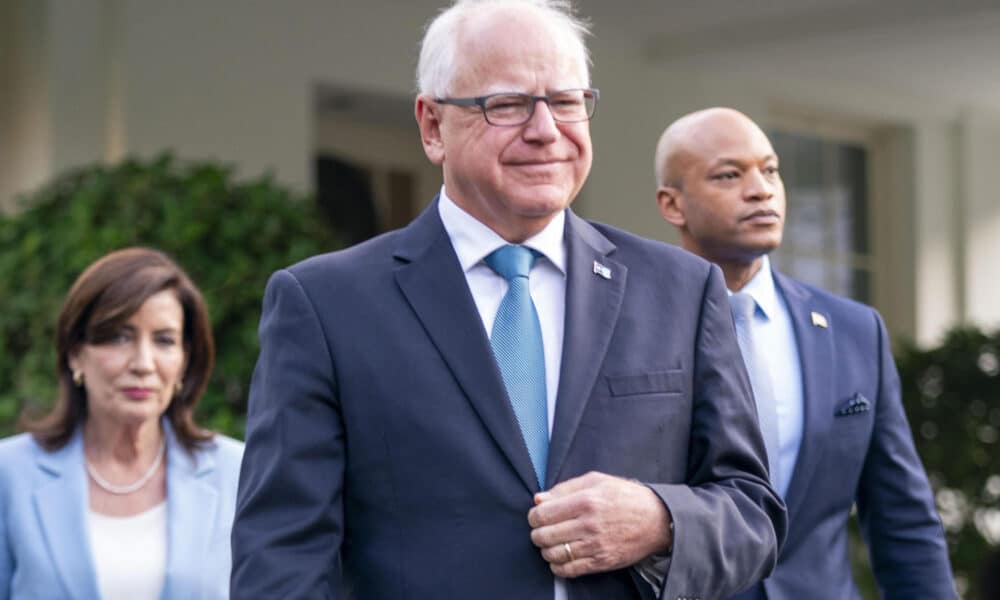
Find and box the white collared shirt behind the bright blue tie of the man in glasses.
[438,187,567,600]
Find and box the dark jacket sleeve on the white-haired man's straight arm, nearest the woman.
[230,271,345,598]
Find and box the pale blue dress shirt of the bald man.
[736,256,804,498]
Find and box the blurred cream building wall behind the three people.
[0,0,1000,342]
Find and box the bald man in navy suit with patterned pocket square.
[655,108,955,600]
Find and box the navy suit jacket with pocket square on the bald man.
[737,272,955,600]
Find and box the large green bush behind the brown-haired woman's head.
[0,154,337,438]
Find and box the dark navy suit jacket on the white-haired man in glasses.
[232,202,785,600]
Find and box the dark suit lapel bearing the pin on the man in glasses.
[546,211,628,488]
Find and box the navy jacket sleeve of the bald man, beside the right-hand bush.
[857,311,956,600]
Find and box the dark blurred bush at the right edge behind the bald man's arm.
[852,327,1000,600]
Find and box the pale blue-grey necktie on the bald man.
[729,292,784,493]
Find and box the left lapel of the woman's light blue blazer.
[34,430,98,599]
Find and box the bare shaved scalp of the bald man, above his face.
[654,107,771,189]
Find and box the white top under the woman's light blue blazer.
[87,501,167,600]
